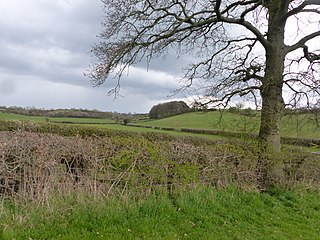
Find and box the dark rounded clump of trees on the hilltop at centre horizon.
[149,101,190,119]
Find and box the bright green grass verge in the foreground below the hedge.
[0,188,320,240]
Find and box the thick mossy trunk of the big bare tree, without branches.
[258,0,289,189]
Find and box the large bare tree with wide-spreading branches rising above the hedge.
[89,0,320,151]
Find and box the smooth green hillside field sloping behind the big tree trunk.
[140,111,320,138]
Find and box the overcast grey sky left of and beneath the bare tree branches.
[0,0,186,112]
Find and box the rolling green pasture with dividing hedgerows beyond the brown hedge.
[0,110,320,152]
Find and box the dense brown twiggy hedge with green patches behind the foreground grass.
[0,122,320,202]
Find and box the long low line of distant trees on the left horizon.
[0,106,147,121]
